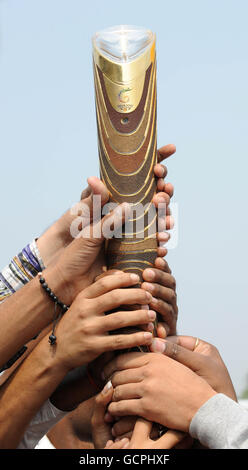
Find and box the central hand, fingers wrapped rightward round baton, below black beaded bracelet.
[51,273,156,372]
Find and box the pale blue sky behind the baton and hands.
[0,0,248,391]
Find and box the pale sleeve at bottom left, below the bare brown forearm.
[17,400,68,449]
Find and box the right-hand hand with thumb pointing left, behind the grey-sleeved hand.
[150,336,237,401]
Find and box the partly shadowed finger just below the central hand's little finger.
[102,352,149,380]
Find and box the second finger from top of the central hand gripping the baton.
[92,288,152,314]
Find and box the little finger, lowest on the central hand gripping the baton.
[98,331,153,352]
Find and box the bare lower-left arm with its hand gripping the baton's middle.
[0,273,155,448]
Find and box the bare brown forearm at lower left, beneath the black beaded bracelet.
[0,337,66,449]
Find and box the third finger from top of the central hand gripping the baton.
[101,310,156,332]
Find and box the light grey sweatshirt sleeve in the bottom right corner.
[189,393,248,449]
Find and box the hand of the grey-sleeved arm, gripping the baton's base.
[104,353,216,432]
